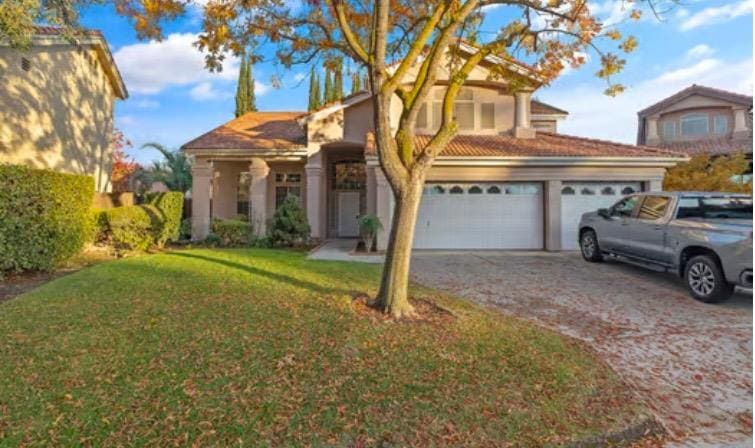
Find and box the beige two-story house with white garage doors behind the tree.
[182,46,684,251]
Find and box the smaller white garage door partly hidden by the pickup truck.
[561,182,640,250]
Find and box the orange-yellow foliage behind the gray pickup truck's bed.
[663,152,752,193]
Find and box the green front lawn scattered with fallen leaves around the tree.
[0,250,641,446]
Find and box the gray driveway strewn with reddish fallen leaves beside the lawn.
[412,252,753,447]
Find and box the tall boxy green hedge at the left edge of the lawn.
[0,164,94,272]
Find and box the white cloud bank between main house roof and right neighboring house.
[539,58,753,143]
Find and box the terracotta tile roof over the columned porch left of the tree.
[181,112,307,149]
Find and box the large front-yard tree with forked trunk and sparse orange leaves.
[4,0,673,317]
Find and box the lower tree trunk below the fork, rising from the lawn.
[378,176,424,318]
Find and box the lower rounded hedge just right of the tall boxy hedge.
[95,192,183,250]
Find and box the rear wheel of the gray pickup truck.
[684,255,734,303]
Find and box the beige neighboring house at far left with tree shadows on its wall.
[0,26,128,191]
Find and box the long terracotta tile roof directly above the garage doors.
[365,131,684,158]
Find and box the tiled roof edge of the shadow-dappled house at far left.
[17,25,128,100]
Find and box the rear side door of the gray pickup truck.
[627,194,673,264]
